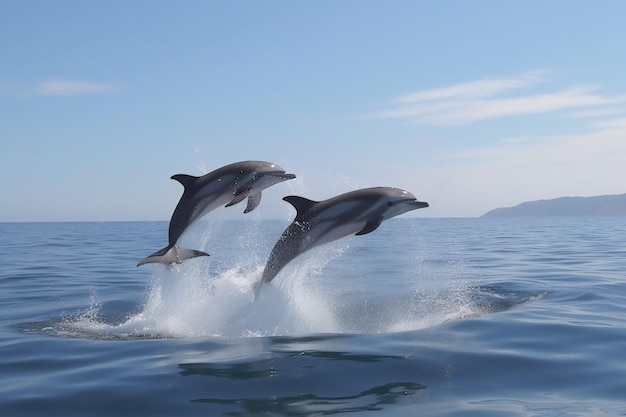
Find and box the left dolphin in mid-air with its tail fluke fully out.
[137,161,296,266]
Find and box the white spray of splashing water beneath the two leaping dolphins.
[57,218,492,338]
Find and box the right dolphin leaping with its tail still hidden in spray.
[261,187,428,283]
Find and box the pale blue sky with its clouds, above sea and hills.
[0,0,626,221]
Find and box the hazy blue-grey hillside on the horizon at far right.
[481,194,626,217]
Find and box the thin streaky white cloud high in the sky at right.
[369,71,626,125]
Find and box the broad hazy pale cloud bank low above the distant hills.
[415,118,626,216]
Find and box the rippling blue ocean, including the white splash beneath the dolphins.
[0,216,626,417]
